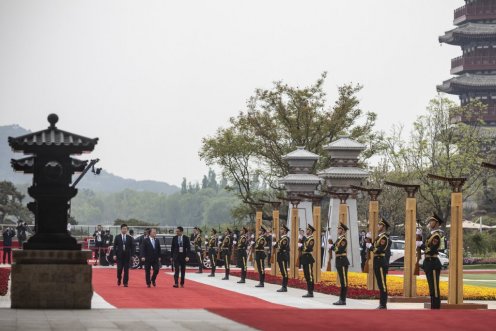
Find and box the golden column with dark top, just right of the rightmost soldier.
[424,174,490,309]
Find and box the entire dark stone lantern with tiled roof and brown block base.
[9,114,98,309]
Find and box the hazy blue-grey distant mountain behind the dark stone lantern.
[0,125,179,194]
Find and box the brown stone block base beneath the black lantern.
[10,250,93,309]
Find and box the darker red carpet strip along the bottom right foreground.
[209,309,496,331]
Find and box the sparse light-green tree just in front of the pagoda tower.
[379,96,491,224]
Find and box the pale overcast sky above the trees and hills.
[0,0,464,185]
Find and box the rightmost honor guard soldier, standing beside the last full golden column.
[417,214,443,309]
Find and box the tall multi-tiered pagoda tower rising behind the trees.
[437,0,496,127]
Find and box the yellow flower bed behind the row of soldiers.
[300,271,496,300]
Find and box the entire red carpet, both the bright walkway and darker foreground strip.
[93,269,496,331]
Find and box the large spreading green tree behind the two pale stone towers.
[199,73,377,210]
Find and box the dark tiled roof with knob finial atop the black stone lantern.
[9,114,98,153]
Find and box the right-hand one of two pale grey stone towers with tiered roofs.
[318,136,369,272]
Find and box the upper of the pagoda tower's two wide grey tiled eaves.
[439,23,496,45]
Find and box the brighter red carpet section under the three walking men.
[93,268,287,310]
